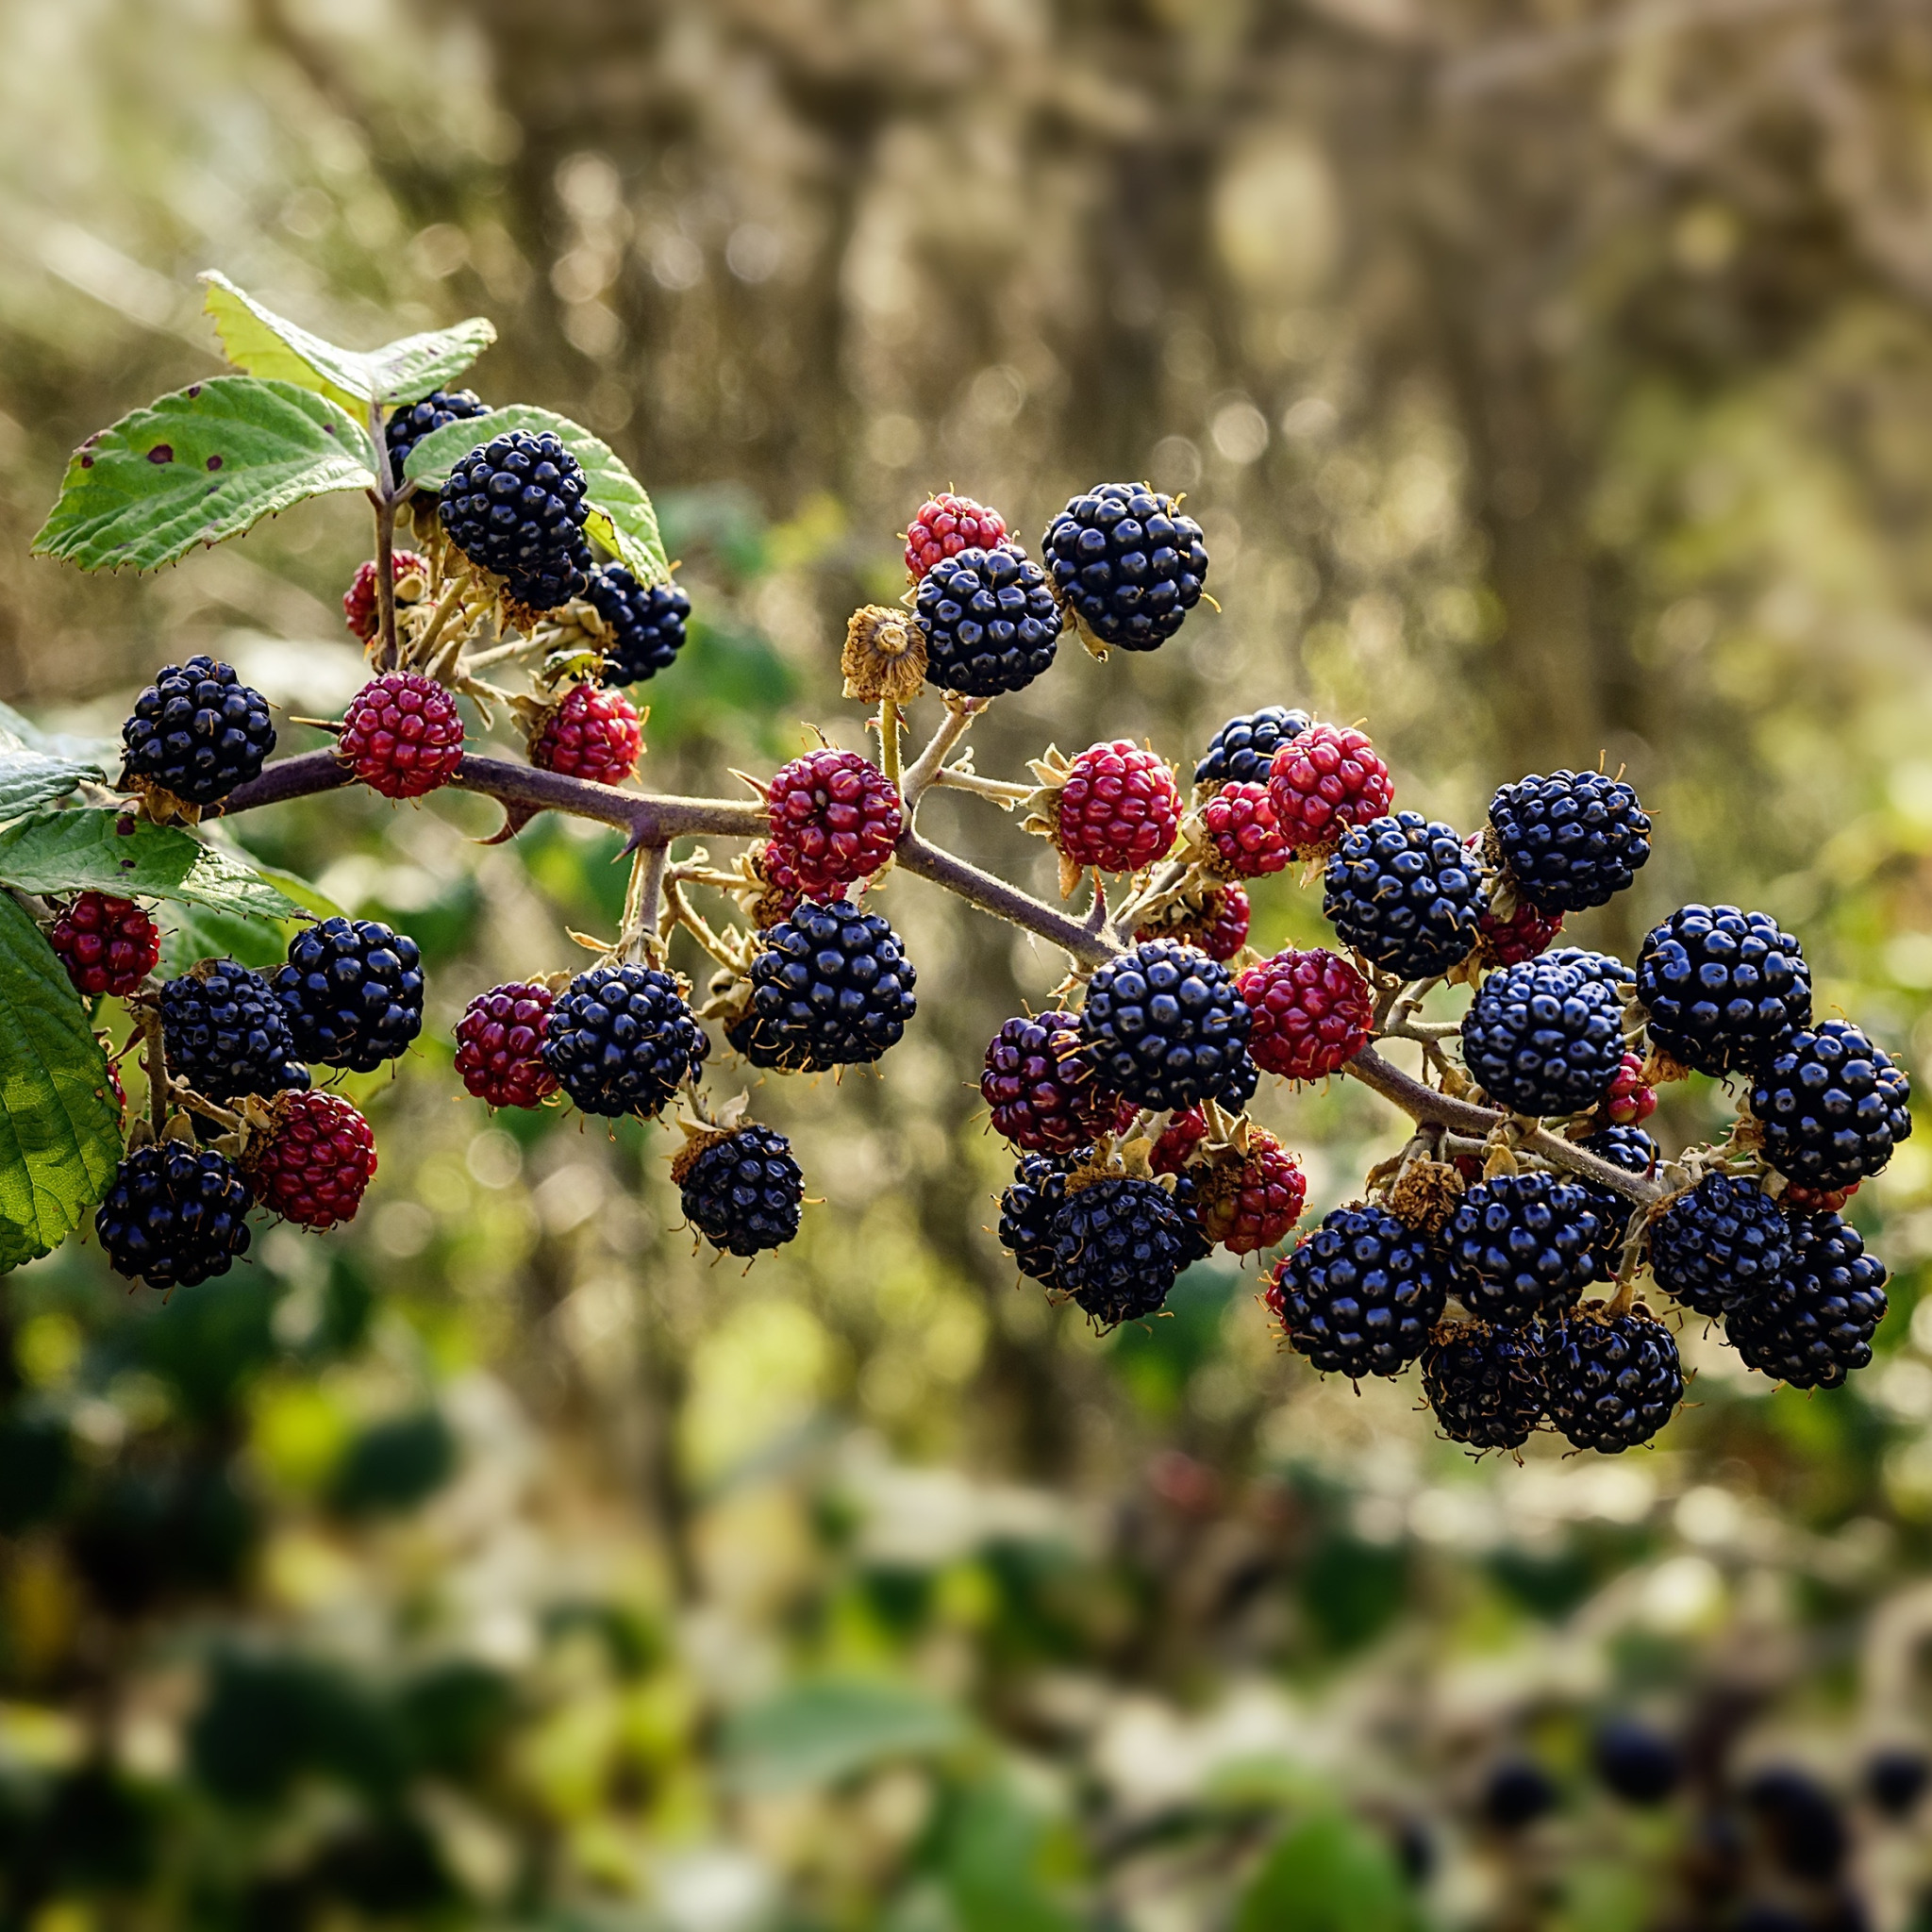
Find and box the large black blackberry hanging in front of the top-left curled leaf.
[437,429,590,610]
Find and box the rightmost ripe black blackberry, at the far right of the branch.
[1750,1020,1913,1189]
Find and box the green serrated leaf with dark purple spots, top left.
[33,375,375,570]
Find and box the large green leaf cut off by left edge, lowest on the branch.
[0,892,122,1267]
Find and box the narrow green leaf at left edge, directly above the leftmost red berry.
[0,806,301,920]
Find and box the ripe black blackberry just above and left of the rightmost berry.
[1637,907,1810,1074]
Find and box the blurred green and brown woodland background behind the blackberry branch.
[0,0,1932,1932]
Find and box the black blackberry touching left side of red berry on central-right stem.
[1080,939,1259,1108]
